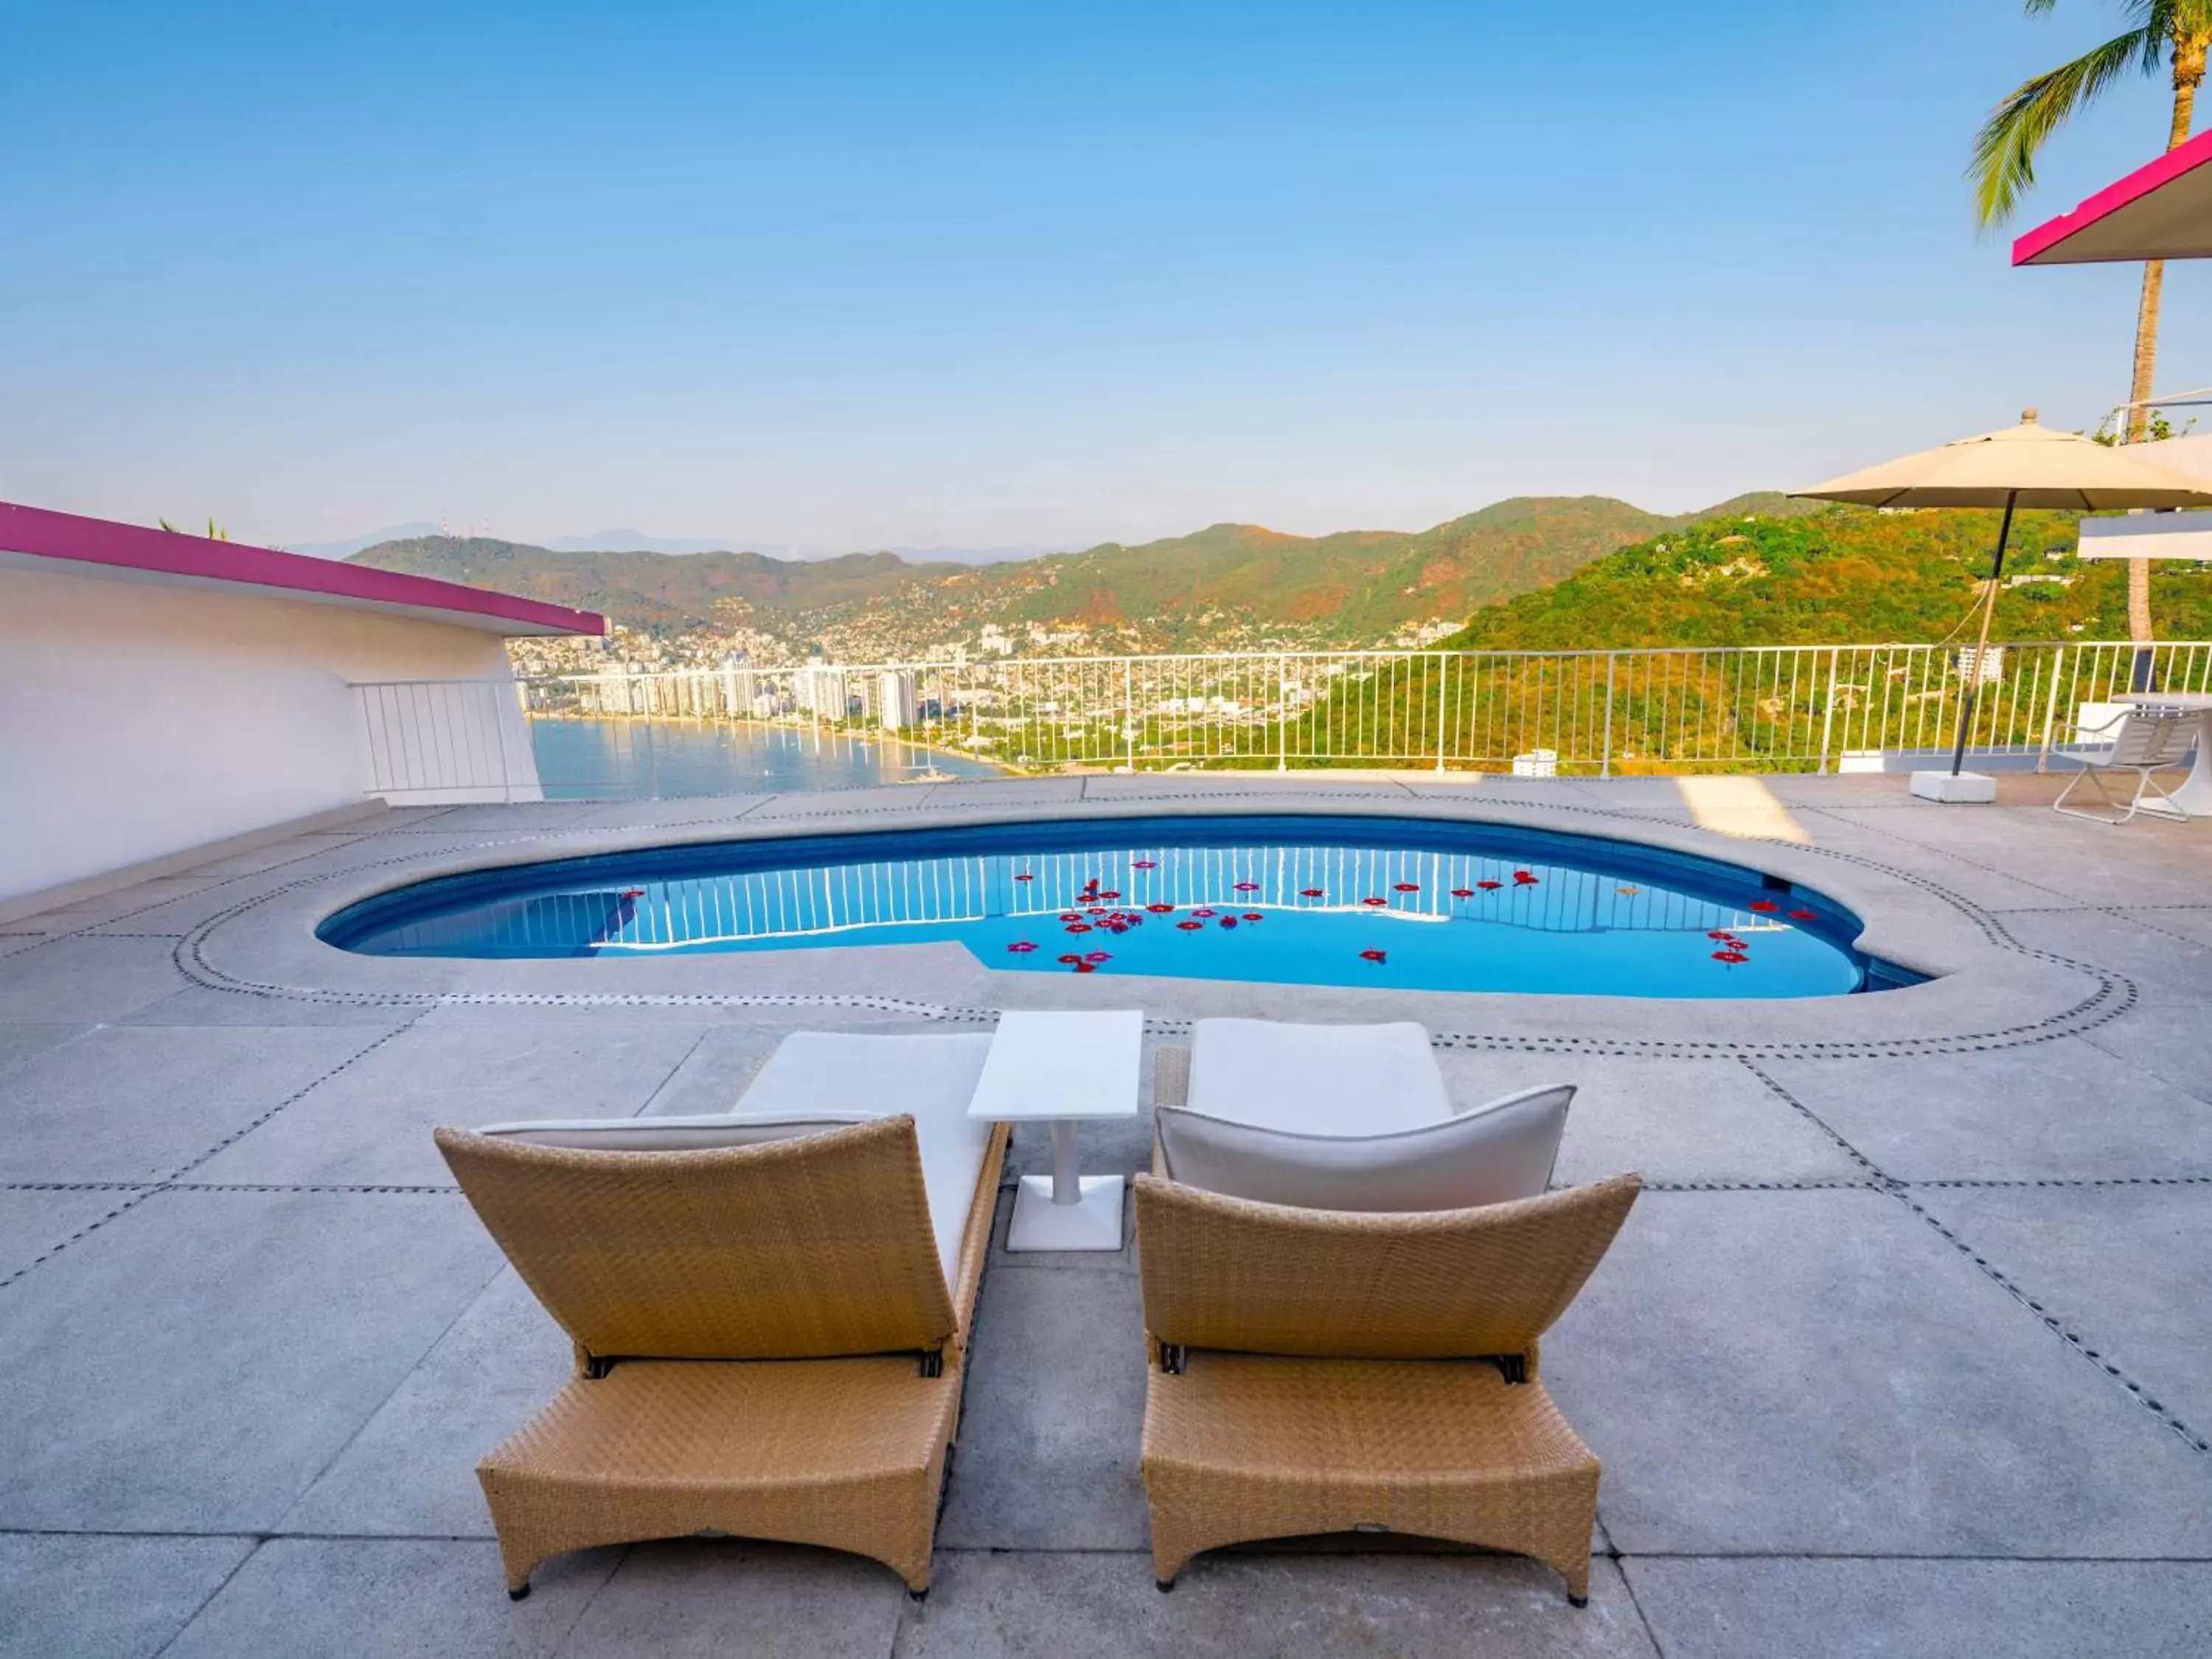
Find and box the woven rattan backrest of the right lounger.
[1137,1175,1641,1358]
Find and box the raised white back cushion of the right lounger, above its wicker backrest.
[1159,1084,1575,1210]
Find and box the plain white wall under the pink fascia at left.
[0,568,535,902]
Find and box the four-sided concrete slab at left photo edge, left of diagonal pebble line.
[0,1026,405,1181]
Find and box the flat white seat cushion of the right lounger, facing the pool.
[1190,1020,1451,1135]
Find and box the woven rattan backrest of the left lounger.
[438,1117,956,1360]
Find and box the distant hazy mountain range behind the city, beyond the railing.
[352,493,1814,659]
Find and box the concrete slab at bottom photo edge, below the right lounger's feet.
[896,1546,1657,1659]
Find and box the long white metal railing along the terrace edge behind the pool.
[358,641,2212,799]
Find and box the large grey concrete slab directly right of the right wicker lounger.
[1544,1192,2212,1557]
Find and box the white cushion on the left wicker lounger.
[478,1031,993,1285]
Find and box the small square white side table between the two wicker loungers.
[969,1009,1144,1250]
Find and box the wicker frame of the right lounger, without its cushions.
[1137,1175,1639,1606]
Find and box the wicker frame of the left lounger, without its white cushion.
[438,1117,1006,1599]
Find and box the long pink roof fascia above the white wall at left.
[0,502,606,635]
